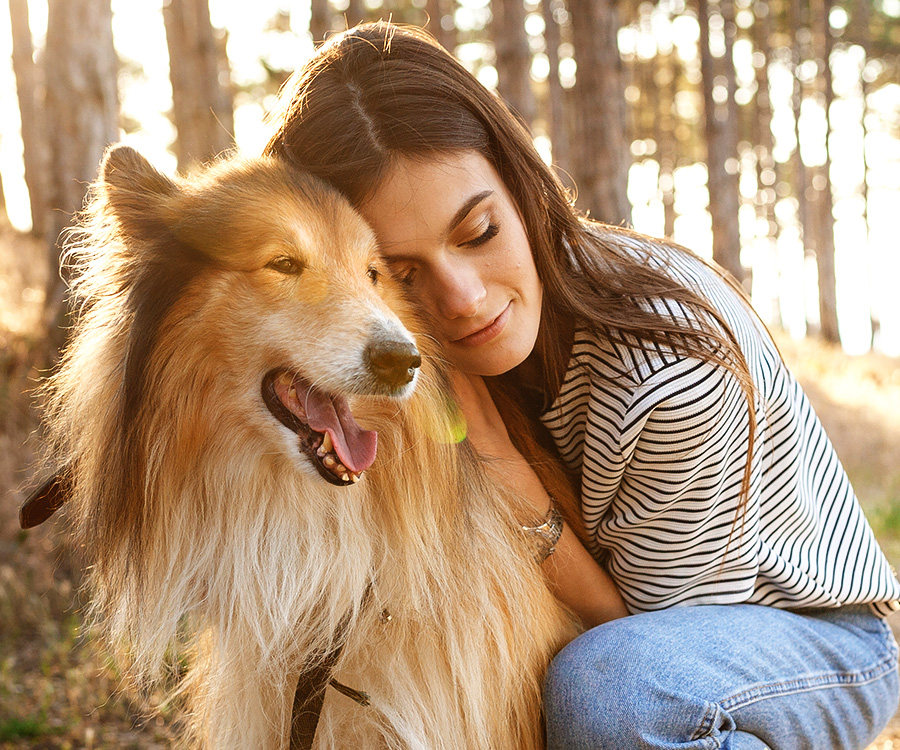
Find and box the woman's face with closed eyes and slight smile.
[360,151,542,375]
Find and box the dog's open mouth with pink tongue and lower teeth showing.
[262,370,377,486]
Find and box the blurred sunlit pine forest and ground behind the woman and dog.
[0,0,900,748]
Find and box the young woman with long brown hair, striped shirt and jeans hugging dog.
[267,24,900,750]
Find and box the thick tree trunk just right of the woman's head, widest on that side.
[569,0,631,224]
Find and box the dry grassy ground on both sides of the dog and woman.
[0,223,900,750]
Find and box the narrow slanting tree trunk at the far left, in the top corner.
[9,0,49,237]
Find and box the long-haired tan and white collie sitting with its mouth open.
[38,146,572,750]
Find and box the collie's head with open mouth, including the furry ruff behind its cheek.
[23,146,432,536]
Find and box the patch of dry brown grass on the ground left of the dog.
[0,226,177,750]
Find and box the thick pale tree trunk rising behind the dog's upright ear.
[45,0,119,346]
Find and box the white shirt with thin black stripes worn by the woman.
[542,241,900,615]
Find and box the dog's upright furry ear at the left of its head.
[98,146,179,240]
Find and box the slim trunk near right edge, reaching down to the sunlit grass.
[812,0,841,344]
